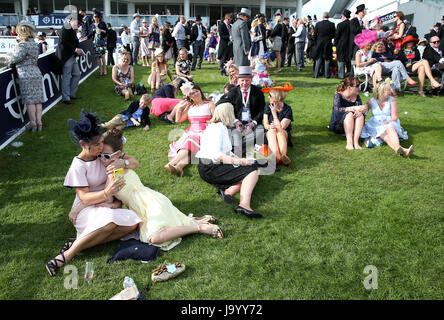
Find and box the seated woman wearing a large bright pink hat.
[355,29,382,87]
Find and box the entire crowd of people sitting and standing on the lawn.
[2,6,444,276]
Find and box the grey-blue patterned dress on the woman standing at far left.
[7,39,45,104]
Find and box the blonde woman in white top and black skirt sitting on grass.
[196,103,262,218]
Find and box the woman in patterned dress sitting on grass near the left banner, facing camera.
[112,52,134,100]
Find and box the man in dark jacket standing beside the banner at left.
[56,13,85,104]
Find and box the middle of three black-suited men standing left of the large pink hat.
[334,9,353,79]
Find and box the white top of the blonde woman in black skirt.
[196,122,232,163]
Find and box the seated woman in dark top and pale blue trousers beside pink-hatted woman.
[372,42,418,97]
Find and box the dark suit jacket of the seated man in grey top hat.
[217,85,265,125]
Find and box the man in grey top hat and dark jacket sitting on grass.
[216,66,265,157]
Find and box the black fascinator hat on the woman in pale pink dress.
[68,109,103,145]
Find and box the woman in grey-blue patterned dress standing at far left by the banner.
[7,21,45,132]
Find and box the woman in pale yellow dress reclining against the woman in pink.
[100,130,223,250]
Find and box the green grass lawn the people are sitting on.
[0,63,444,300]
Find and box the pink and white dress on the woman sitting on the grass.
[168,103,212,158]
